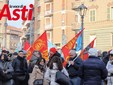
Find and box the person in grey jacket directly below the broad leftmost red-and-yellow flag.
[29,50,42,73]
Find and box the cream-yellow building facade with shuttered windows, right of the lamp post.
[80,0,113,51]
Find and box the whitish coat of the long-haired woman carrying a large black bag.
[45,63,69,85]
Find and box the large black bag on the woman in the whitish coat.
[55,71,70,85]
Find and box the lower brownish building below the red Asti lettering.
[6,26,23,52]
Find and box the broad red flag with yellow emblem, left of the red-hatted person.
[27,31,48,60]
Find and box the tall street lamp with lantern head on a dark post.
[73,4,87,49]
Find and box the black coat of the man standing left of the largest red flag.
[12,56,28,79]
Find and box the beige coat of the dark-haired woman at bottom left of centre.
[29,65,49,85]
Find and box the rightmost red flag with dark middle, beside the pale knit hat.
[80,38,96,60]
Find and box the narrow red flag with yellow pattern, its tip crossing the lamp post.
[62,29,84,66]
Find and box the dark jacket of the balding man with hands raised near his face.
[66,57,82,78]
